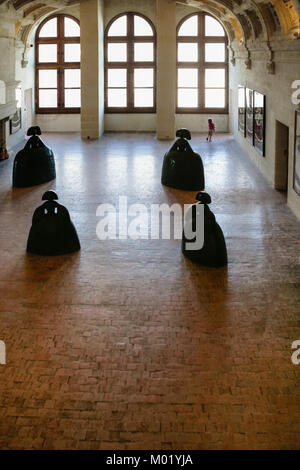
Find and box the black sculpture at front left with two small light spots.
[27,191,80,256]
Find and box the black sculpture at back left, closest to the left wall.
[13,126,56,188]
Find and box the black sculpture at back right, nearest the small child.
[161,129,205,191]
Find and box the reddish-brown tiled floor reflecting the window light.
[0,134,300,450]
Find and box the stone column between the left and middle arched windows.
[80,0,104,139]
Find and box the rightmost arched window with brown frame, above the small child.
[177,13,228,113]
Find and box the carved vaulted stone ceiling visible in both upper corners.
[0,0,300,44]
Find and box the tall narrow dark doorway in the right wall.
[275,121,289,193]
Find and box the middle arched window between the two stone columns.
[105,13,156,113]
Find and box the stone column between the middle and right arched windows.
[156,0,176,140]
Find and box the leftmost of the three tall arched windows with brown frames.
[35,15,80,114]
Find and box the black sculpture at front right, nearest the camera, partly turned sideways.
[182,192,228,268]
